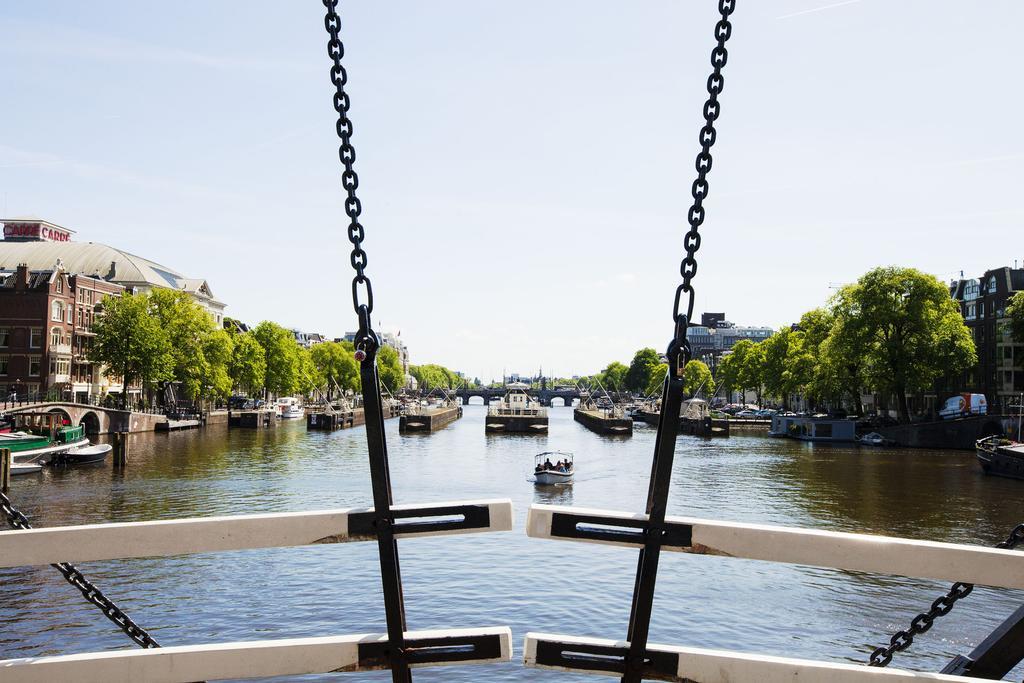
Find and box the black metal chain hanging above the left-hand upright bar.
[324,0,374,321]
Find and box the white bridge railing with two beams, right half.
[523,505,1024,683]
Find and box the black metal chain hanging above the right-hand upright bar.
[668,0,736,372]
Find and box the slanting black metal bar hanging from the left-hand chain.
[359,331,413,683]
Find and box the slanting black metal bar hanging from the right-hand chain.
[622,371,683,683]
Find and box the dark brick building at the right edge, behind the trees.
[949,267,1024,413]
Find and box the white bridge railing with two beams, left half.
[0,500,512,683]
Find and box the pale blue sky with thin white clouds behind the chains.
[0,0,1024,380]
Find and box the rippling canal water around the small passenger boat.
[0,405,1024,681]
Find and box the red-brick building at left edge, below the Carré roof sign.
[0,260,123,400]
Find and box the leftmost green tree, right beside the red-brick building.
[89,294,174,410]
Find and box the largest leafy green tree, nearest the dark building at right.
[838,267,977,422]
